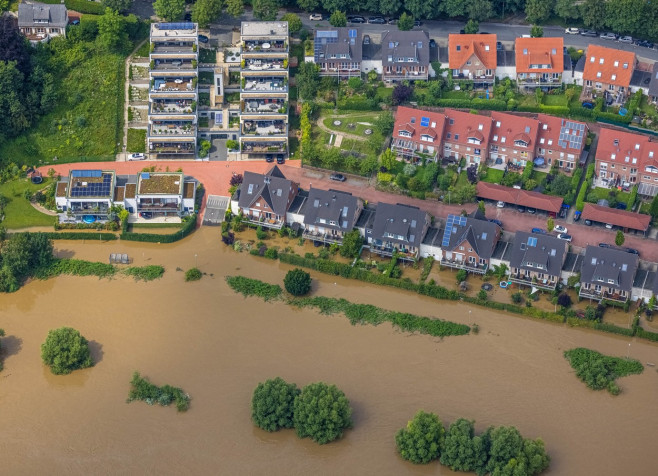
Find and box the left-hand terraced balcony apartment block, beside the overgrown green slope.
[146,23,199,159]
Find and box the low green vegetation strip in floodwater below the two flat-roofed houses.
[36,258,164,281]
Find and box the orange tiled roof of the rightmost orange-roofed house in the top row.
[583,45,635,88]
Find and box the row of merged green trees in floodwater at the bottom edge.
[395,410,550,476]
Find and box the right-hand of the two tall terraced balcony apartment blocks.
[240,21,289,159]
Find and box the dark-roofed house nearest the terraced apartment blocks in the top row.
[313,27,363,79]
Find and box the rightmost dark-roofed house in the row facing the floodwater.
[579,245,639,302]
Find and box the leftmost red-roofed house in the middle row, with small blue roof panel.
[391,107,446,161]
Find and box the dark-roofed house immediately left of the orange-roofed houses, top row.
[381,30,430,82]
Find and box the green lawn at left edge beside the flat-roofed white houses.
[0,177,55,229]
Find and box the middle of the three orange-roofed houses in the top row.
[515,37,565,89]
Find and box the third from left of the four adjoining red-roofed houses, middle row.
[489,112,539,168]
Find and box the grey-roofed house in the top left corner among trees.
[18,2,69,44]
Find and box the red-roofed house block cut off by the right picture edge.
[596,128,658,197]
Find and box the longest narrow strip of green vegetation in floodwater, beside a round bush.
[226,276,471,337]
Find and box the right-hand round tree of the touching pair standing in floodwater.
[294,382,352,445]
